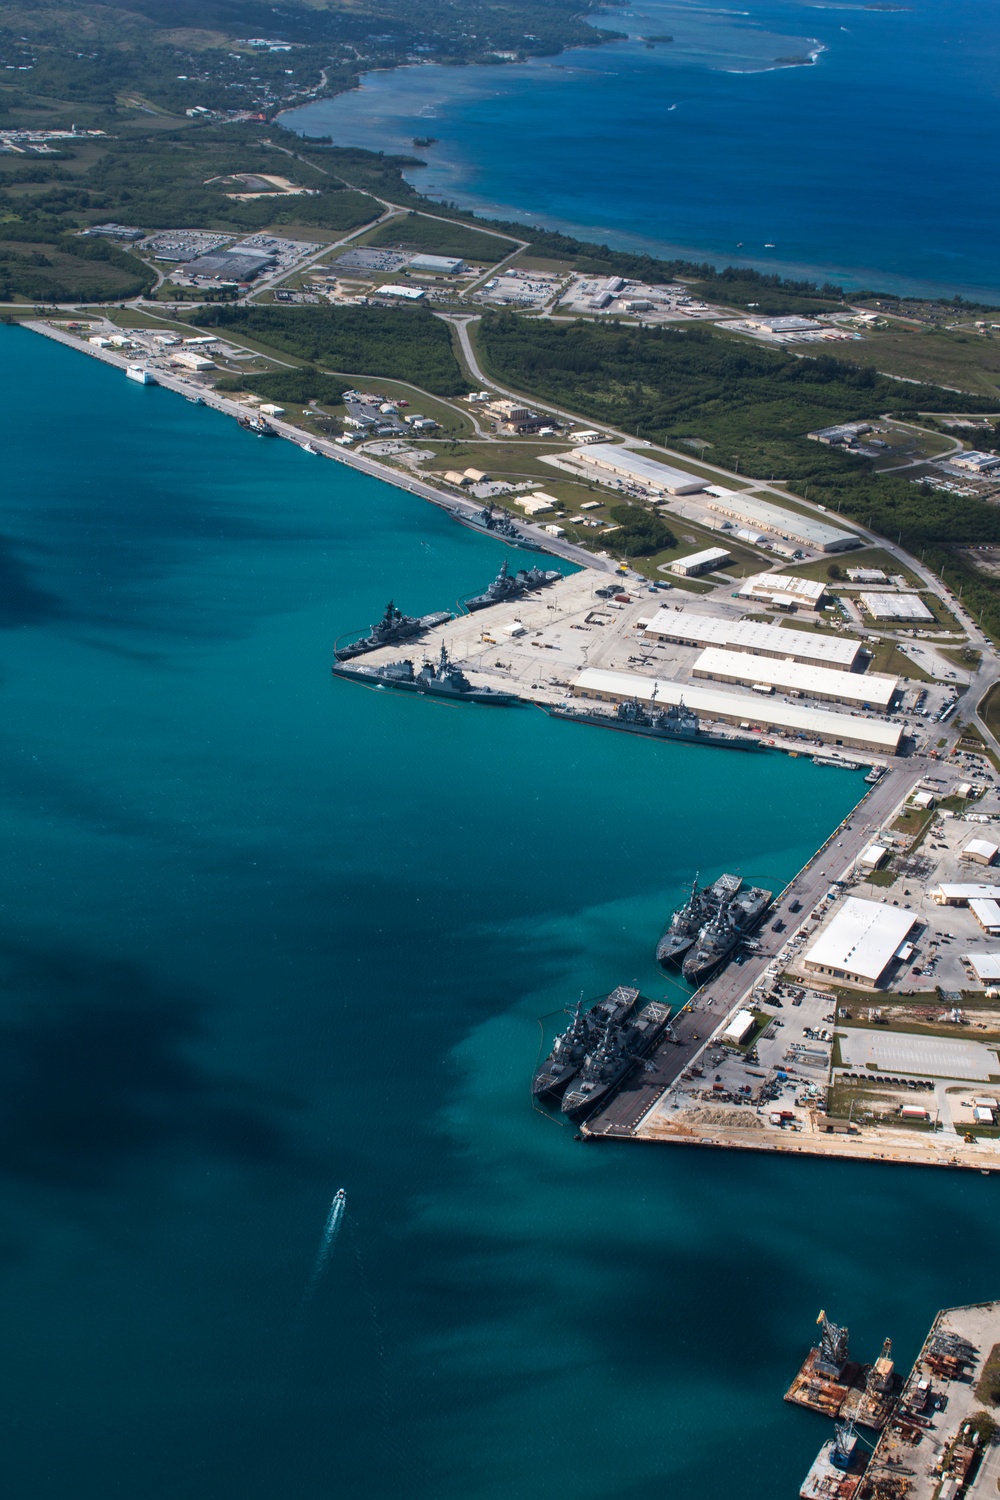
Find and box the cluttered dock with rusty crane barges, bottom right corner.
[784,1302,1000,1500]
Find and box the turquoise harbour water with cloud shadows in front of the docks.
[0,329,1000,1500]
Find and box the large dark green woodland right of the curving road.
[478,314,1000,638]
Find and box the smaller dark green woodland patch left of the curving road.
[198,305,471,396]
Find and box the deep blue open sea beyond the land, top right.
[283,0,1000,303]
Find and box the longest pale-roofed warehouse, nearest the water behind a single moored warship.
[571,668,903,755]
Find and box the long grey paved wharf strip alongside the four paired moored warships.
[583,756,937,1136]
